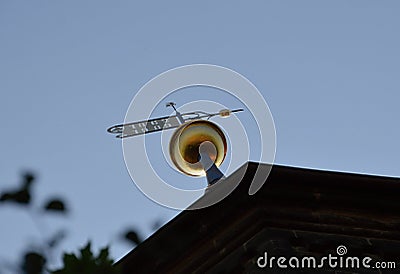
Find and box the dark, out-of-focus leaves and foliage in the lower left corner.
[0,172,148,274]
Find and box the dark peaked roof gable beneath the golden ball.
[117,163,400,273]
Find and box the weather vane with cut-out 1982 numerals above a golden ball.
[107,102,243,185]
